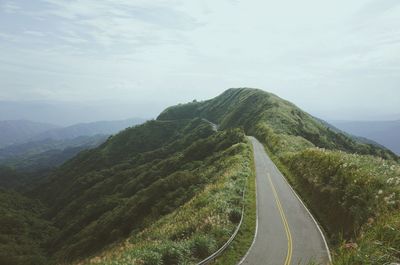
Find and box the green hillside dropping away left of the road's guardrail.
[0,119,251,265]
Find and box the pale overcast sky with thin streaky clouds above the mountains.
[0,0,400,119]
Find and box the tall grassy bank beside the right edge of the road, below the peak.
[253,121,400,265]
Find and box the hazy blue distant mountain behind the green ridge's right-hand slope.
[331,120,400,155]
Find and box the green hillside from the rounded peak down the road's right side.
[158,88,400,264]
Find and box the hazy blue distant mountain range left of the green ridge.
[0,119,144,171]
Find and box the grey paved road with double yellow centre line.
[241,137,329,265]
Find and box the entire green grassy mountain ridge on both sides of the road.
[0,88,400,265]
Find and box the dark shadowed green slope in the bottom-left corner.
[0,189,56,265]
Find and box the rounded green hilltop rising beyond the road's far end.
[157,88,398,159]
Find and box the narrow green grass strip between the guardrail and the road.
[213,137,257,265]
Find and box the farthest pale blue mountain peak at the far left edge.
[0,120,58,147]
